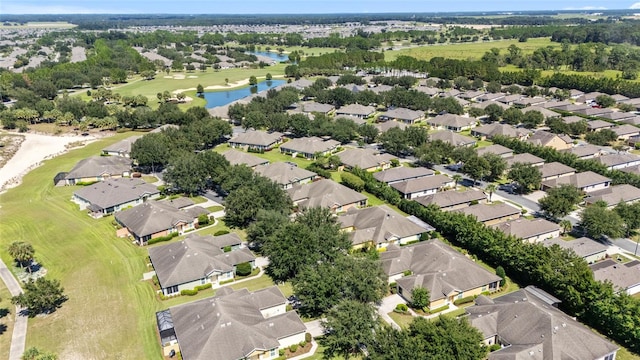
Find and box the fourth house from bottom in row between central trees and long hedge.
[287,179,367,213]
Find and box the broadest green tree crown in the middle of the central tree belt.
[262,207,351,281]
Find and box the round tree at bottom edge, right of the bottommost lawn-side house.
[322,300,378,359]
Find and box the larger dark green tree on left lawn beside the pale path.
[11,277,67,317]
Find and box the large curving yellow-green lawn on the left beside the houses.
[0,133,167,359]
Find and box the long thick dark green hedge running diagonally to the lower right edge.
[353,169,640,353]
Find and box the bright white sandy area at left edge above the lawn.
[0,133,95,191]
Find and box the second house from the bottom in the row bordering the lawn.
[149,233,256,296]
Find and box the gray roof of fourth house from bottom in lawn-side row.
[73,178,160,209]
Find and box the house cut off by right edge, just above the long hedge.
[591,259,640,295]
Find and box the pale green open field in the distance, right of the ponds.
[384,38,560,61]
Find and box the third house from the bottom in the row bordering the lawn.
[115,200,209,245]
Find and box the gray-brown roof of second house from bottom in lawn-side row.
[149,234,255,288]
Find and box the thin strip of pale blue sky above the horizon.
[0,0,640,14]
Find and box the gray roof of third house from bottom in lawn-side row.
[115,200,209,237]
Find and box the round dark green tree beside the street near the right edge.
[580,201,624,240]
